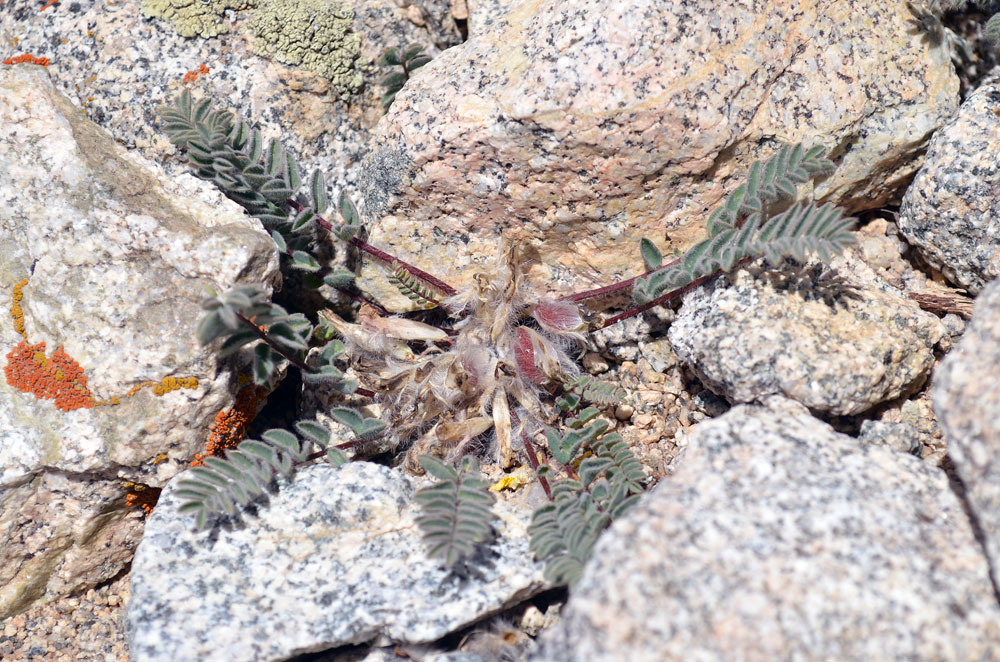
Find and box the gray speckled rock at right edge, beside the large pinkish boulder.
[898,76,1000,294]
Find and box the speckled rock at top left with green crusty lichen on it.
[0,0,461,199]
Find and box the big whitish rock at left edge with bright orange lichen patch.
[0,66,278,617]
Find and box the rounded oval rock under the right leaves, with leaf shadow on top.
[669,265,946,415]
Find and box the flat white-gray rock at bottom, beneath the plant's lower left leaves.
[126,462,545,662]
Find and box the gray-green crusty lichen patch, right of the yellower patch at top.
[250,0,363,97]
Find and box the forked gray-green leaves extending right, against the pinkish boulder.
[632,145,855,304]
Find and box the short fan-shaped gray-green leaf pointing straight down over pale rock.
[416,455,496,568]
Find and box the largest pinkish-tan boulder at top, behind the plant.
[362,0,958,306]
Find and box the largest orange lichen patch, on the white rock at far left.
[3,340,98,411]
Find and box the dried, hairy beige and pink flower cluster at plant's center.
[325,241,582,472]
